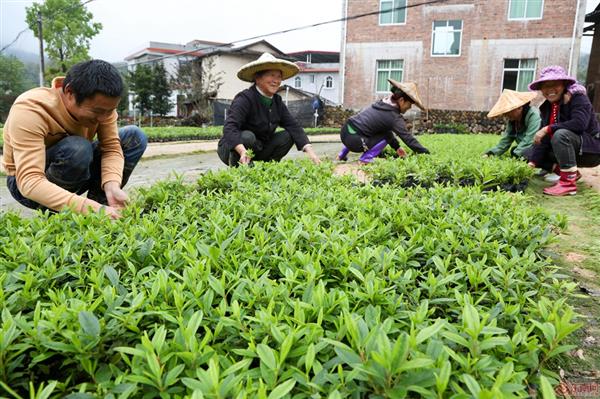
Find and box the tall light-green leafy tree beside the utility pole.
[26,0,102,76]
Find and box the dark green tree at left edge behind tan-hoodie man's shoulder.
[0,54,35,122]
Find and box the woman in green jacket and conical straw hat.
[485,89,542,159]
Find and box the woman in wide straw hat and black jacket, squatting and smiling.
[217,53,320,166]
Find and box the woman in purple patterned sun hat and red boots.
[529,65,600,195]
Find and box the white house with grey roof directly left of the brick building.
[283,50,341,104]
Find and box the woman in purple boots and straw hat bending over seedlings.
[337,79,429,164]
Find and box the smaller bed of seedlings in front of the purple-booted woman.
[366,135,533,192]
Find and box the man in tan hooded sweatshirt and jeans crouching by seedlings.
[3,60,147,219]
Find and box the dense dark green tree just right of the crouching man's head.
[129,63,172,115]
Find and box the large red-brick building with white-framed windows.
[341,0,585,111]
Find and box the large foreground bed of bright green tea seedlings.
[0,155,579,399]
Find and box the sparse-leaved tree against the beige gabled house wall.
[171,57,223,123]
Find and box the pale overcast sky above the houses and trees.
[0,0,599,62]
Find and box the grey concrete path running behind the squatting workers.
[0,141,341,216]
